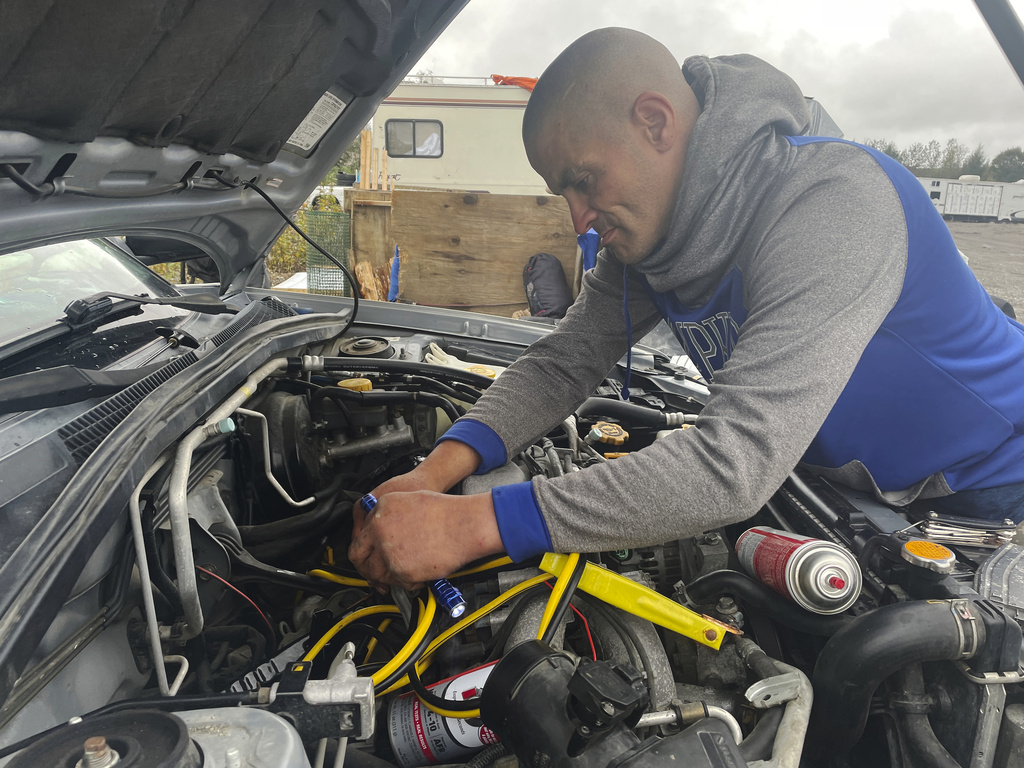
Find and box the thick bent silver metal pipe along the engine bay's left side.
[167,357,288,640]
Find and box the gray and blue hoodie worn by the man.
[445,55,1024,559]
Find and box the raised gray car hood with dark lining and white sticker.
[0,0,466,293]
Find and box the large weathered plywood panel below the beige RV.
[393,189,577,316]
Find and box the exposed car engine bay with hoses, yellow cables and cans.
[0,334,1024,768]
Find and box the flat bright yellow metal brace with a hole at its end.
[541,552,742,650]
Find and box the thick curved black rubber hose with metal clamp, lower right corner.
[807,600,984,755]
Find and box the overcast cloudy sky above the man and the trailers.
[415,0,1024,158]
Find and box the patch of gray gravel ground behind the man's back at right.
[948,221,1024,317]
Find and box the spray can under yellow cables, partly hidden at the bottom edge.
[388,664,499,768]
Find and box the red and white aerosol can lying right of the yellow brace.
[736,526,861,614]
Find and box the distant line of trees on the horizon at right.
[863,138,1024,182]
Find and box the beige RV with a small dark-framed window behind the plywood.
[373,76,545,195]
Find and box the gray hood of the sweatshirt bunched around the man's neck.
[636,54,811,296]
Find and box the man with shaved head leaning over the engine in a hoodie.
[349,29,1024,587]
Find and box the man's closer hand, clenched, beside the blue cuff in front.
[348,489,503,590]
